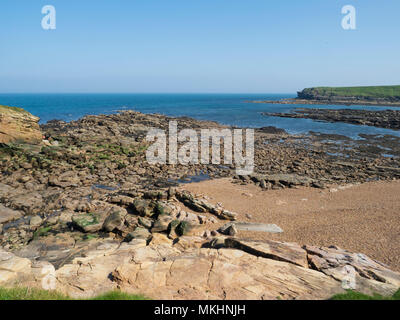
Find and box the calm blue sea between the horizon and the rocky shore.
[0,94,400,138]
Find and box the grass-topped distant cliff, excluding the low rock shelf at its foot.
[298,85,400,100]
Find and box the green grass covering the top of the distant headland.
[303,86,400,98]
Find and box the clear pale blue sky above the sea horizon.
[0,0,400,93]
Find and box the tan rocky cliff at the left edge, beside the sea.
[0,105,43,144]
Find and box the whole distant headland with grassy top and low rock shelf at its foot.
[250,85,400,107]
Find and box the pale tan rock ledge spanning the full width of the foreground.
[0,238,400,300]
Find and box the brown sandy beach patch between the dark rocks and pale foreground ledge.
[183,178,400,271]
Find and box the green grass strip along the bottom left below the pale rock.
[0,287,148,300]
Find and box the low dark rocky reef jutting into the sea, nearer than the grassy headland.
[262,108,400,130]
